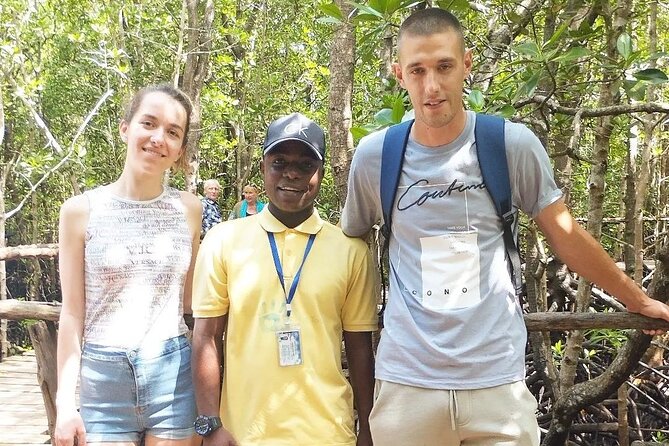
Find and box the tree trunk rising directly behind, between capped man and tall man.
[328,0,355,209]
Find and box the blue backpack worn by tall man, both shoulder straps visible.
[379,113,522,315]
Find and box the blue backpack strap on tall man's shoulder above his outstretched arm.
[474,113,522,295]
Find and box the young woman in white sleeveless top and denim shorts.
[55,85,202,446]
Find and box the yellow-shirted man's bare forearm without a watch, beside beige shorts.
[344,331,374,446]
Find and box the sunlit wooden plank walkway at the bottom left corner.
[0,352,50,446]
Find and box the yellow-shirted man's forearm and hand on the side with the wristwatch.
[192,315,237,446]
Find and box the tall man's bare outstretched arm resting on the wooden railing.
[534,200,669,334]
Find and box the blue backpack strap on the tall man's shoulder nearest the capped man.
[380,119,414,237]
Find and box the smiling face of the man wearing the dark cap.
[261,141,323,221]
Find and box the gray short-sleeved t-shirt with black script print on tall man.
[341,112,562,389]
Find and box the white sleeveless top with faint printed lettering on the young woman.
[84,186,192,349]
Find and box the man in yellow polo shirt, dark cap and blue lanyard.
[192,113,377,446]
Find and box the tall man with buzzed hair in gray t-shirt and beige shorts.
[341,8,669,446]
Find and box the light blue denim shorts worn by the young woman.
[79,336,197,443]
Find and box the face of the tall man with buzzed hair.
[393,30,472,128]
